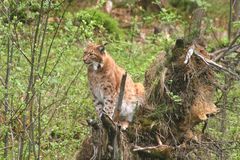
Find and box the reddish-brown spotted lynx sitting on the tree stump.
[83,43,144,128]
